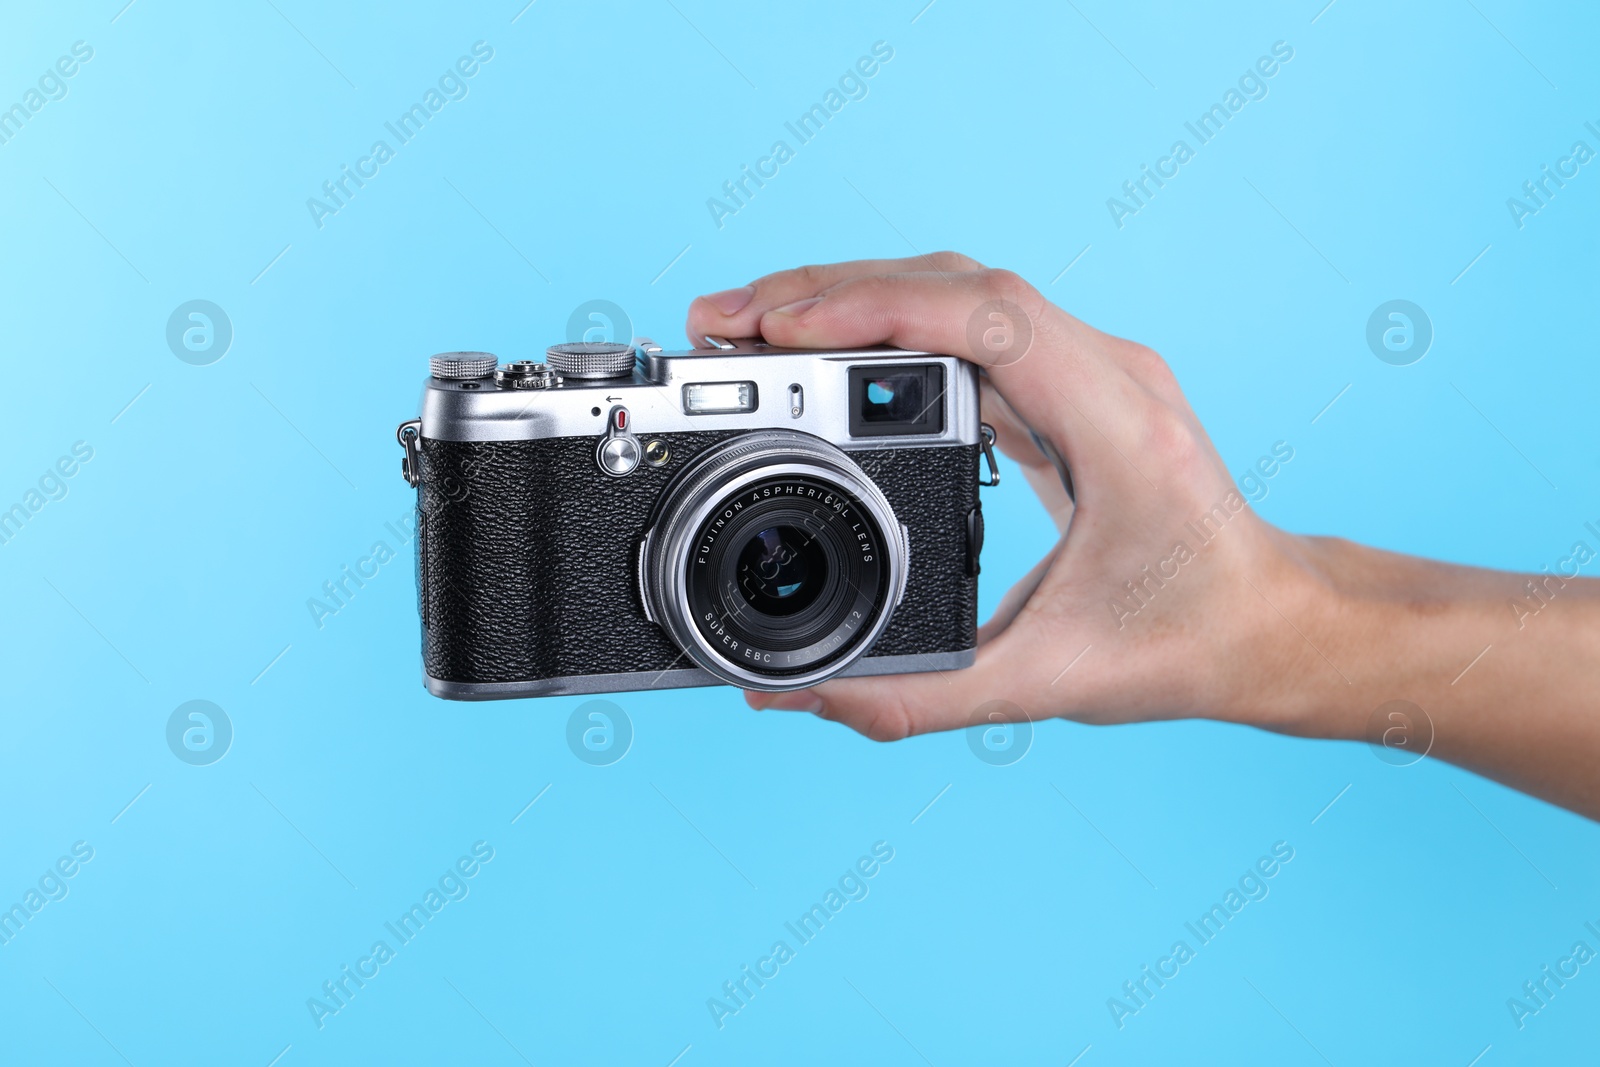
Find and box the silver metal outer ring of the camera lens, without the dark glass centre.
[640,430,909,693]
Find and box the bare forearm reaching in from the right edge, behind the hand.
[1251,536,1600,819]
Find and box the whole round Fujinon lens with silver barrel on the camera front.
[640,430,906,689]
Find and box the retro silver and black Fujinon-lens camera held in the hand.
[398,338,998,701]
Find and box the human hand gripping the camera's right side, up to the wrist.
[688,253,1318,741]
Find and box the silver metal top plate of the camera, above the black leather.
[421,341,979,450]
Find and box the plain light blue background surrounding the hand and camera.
[0,0,1600,1067]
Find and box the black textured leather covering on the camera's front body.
[416,432,978,681]
